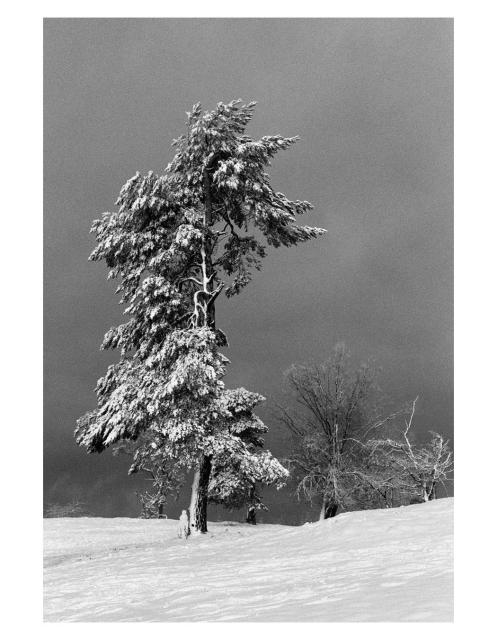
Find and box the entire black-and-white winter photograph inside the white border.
[38,12,458,624]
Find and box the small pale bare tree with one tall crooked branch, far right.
[369,398,453,502]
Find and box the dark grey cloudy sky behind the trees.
[44,19,453,523]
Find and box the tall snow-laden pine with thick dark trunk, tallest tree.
[72,101,324,532]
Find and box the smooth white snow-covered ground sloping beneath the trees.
[44,498,453,622]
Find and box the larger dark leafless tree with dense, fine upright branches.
[279,344,398,519]
